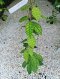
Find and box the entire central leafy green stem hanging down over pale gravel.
[19,0,44,74]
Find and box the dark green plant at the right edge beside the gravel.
[47,0,60,24]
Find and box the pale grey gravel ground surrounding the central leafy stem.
[0,0,60,79]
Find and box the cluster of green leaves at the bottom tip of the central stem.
[22,48,43,74]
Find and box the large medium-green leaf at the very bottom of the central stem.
[27,56,39,74]
